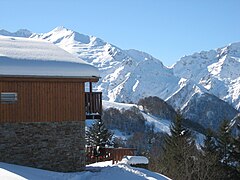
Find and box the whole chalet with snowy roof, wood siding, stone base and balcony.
[0,36,102,172]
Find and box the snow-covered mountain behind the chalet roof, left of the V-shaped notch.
[30,27,184,102]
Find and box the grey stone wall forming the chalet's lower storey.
[0,121,85,172]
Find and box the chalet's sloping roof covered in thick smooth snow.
[0,36,100,78]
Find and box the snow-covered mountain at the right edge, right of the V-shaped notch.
[173,43,240,109]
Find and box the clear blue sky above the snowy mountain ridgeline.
[0,0,240,65]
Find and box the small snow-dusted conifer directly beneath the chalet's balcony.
[86,119,112,147]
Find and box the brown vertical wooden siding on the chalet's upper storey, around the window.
[0,78,86,122]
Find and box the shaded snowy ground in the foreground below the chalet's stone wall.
[0,161,169,180]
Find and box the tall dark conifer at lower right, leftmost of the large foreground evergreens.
[159,113,196,180]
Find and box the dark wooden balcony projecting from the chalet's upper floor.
[85,92,102,119]
